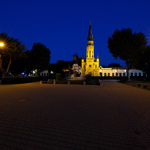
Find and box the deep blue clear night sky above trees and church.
[0,0,150,66]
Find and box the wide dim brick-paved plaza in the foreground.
[0,81,150,150]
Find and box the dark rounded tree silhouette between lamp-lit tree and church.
[30,43,51,73]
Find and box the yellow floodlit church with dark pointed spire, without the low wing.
[81,23,99,76]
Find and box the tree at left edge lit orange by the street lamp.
[0,33,26,77]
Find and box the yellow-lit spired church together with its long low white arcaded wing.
[78,23,144,77]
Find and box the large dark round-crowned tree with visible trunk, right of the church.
[107,28,147,80]
